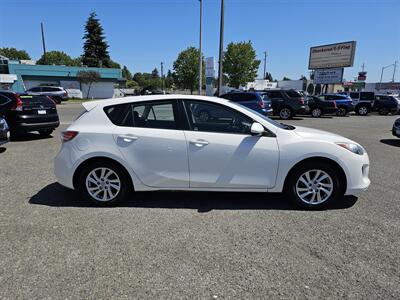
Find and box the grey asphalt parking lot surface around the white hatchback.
[0,104,400,299]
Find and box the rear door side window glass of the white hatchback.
[104,101,177,129]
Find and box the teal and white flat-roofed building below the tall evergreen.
[0,57,124,99]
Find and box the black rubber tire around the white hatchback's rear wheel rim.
[78,160,133,206]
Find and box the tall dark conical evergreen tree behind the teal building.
[82,12,111,68]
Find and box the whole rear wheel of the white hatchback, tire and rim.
[78,161,132,206]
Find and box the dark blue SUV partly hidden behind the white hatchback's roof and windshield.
[221,92,272,116]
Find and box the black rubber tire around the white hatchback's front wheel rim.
[284,162,343,210]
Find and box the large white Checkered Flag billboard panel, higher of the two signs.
[308,41,356,70]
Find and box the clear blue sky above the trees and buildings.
[0,0,400,81]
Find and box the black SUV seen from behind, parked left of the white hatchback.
[0,91,60,135]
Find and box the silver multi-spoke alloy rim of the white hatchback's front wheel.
[295,169,333,205]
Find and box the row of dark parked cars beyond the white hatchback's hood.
[221,89,400,120]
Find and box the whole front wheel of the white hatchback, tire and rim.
[286,162,343,209]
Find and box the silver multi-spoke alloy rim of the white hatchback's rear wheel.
[86,167,121,202]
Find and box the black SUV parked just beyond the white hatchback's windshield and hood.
[263,90,309,120]
